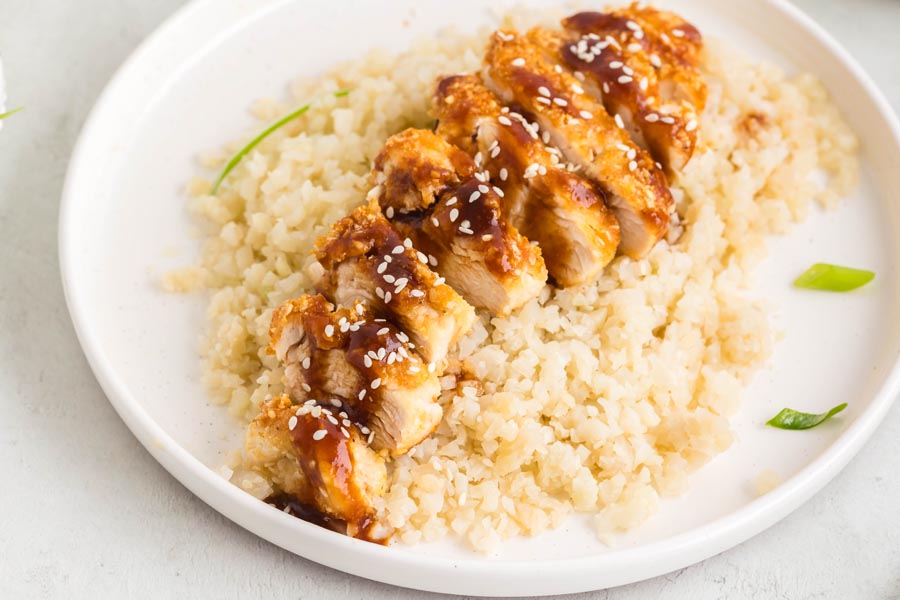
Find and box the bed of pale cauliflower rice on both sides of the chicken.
[164,19,856,551]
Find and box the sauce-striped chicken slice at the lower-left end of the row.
[244,395,387,536]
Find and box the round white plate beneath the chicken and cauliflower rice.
[60,0,900,595]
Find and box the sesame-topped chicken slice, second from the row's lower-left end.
[269,295,442,456]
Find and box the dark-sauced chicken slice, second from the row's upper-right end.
[528,25,697,173]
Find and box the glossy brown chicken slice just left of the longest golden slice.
[434,75,619,287]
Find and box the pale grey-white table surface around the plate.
[0,0,900,600]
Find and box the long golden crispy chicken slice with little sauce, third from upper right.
[483,31,672,258]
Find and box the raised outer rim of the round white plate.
[58,0,900,596]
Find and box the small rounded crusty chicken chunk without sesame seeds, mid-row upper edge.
[372,129,475,218]
